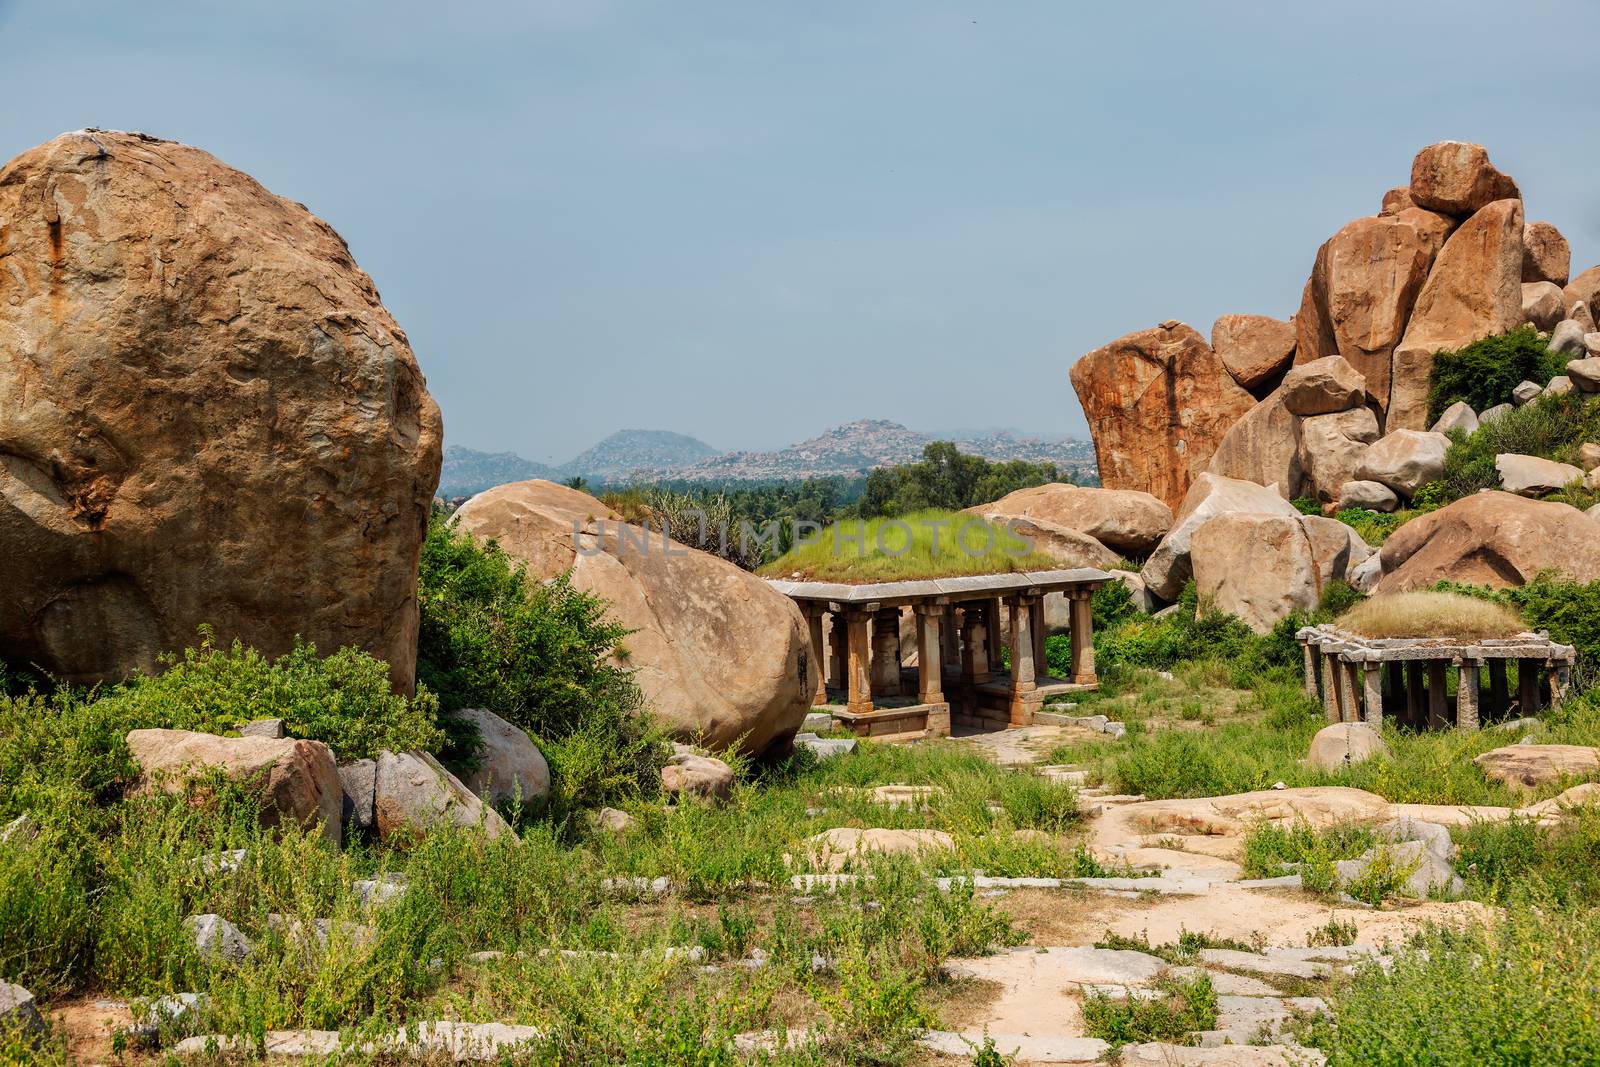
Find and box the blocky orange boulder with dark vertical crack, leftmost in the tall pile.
[1072,320,1256,507]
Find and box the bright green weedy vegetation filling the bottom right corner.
[1304,901,1600,1067]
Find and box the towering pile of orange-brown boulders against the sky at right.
[1072,141,1600,509]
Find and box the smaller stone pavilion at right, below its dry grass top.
[1294,625,1576,729]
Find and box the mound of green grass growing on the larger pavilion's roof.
[758,509,1061,582]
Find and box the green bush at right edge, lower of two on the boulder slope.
[1438,390,1600,502]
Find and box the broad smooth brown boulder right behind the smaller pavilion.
[1378,491,1600,593]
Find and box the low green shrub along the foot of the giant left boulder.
[84,630,443,761]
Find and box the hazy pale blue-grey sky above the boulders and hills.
[0,0,1600,461]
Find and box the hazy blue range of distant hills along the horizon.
[438,419,1094,498]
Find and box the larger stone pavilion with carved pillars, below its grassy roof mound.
[770,568,1112,739]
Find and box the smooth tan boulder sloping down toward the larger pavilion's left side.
[456,480,821,752]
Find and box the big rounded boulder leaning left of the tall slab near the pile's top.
[1294,205,1456,411]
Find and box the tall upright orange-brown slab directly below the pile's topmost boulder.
[1384,199,1522,430]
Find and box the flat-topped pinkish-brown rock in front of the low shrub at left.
[128,729,344,845]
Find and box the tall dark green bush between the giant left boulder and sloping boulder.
[416,518,666,808]
